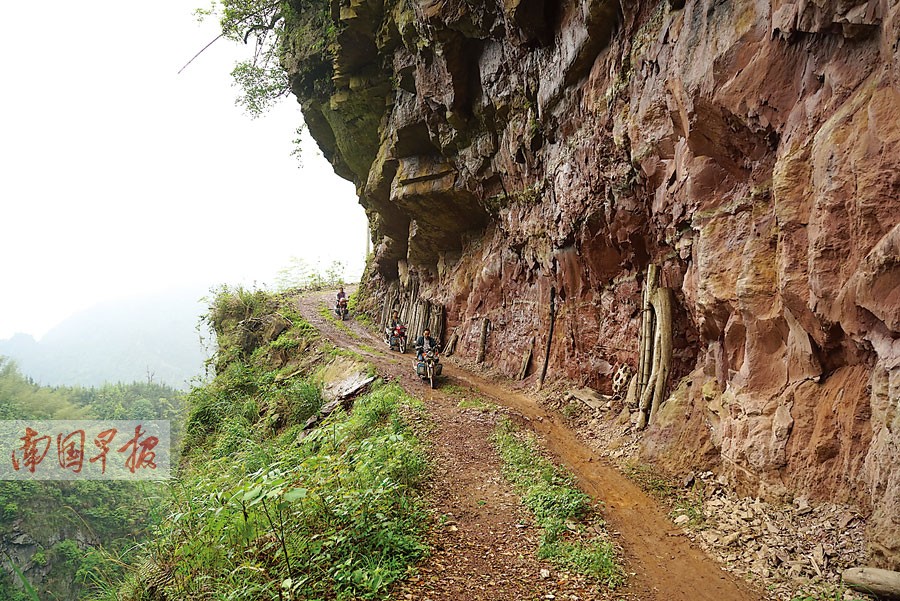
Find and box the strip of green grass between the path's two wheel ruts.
[492,420,625,589]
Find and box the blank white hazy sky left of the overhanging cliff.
[0,0,367,339]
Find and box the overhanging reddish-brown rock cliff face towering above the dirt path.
[286,0,900,568]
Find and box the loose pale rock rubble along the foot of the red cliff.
[556,392,872,601]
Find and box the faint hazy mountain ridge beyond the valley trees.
[0,288,207,388]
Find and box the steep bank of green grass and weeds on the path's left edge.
[97,289,427,601]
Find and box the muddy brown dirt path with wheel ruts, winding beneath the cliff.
[298,292,763,601]
